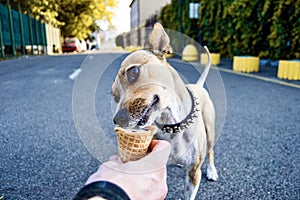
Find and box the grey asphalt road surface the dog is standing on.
[0,54,300,200]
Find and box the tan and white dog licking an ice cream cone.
[112,23,218,199]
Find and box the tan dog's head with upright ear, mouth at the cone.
[112,23,185,127]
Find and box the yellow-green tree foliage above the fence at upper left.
[1,0,116,39]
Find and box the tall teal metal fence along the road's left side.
[0,4,60,58]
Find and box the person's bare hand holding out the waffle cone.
[86,140,171,200]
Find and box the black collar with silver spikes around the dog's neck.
[154,88,199,133]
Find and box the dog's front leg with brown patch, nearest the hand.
[185,159,204,200]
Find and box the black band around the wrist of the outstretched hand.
[73,181,130,200]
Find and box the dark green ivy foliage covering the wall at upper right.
[160,0,300,59]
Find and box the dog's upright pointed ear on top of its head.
[147,23,171,54]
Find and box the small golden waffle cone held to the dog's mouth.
[115,126,157,162]
